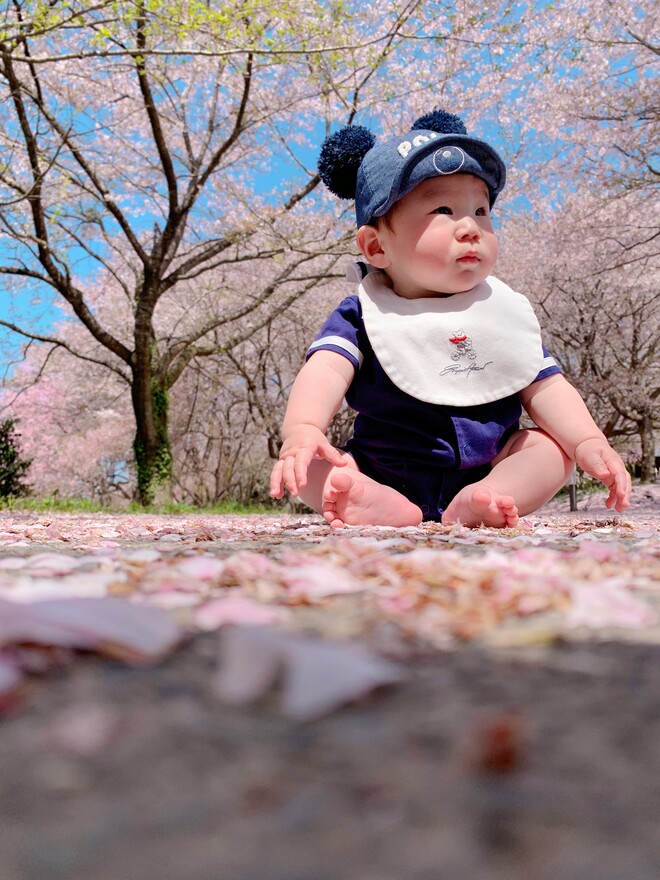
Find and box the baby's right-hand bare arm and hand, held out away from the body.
[520,374,630,512]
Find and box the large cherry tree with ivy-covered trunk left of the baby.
[0,0,532,502]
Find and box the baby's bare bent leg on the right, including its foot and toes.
[442,429,572,528]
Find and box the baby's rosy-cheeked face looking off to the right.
[378,174,497,299]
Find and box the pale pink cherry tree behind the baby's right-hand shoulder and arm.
[500,187,660,481]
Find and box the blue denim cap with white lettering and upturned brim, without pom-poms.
[355,129,506,227]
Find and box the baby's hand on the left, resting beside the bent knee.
[270,425,346,498]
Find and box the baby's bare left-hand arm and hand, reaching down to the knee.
[270,350,355,498]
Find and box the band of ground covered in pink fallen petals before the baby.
[0,487,660,715]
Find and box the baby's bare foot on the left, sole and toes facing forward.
[323,473,422,529]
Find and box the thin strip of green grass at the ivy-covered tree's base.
[0,498,278,515]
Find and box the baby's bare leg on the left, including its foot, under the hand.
[300,457,422,529]
